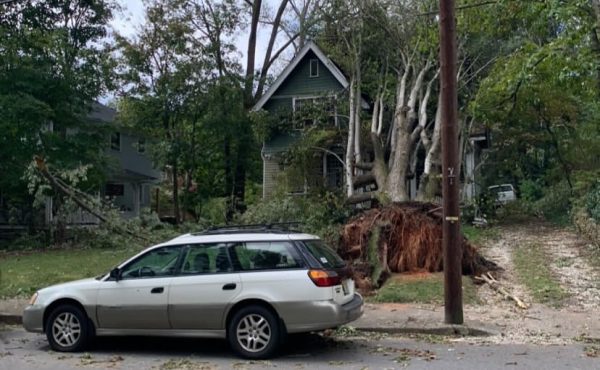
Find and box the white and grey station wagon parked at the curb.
[23,226,363,358]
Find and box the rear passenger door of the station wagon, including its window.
[169,244,242,330]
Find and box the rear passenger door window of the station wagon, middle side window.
[181,243,233,275]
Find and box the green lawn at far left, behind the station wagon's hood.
[0,248,137,298]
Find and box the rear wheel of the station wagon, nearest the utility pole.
[227,305,282,359]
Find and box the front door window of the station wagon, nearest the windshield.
[121,246,183,279]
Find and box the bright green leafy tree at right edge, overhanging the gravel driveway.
[471,0,600,197]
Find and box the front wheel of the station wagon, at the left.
[46,305,93,352]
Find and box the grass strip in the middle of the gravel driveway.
[512,244,568,307]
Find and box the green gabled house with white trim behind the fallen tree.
[252,42,368,198]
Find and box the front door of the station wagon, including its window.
[96,246,183,329]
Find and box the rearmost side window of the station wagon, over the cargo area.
[232,241,303,271]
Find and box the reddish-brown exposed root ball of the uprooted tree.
[339,202,499,289]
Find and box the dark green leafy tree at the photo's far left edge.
[0,0,115,228]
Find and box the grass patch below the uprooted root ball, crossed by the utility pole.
[369,272,479,304]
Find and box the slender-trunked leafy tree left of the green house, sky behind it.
[117,0,204,222]
